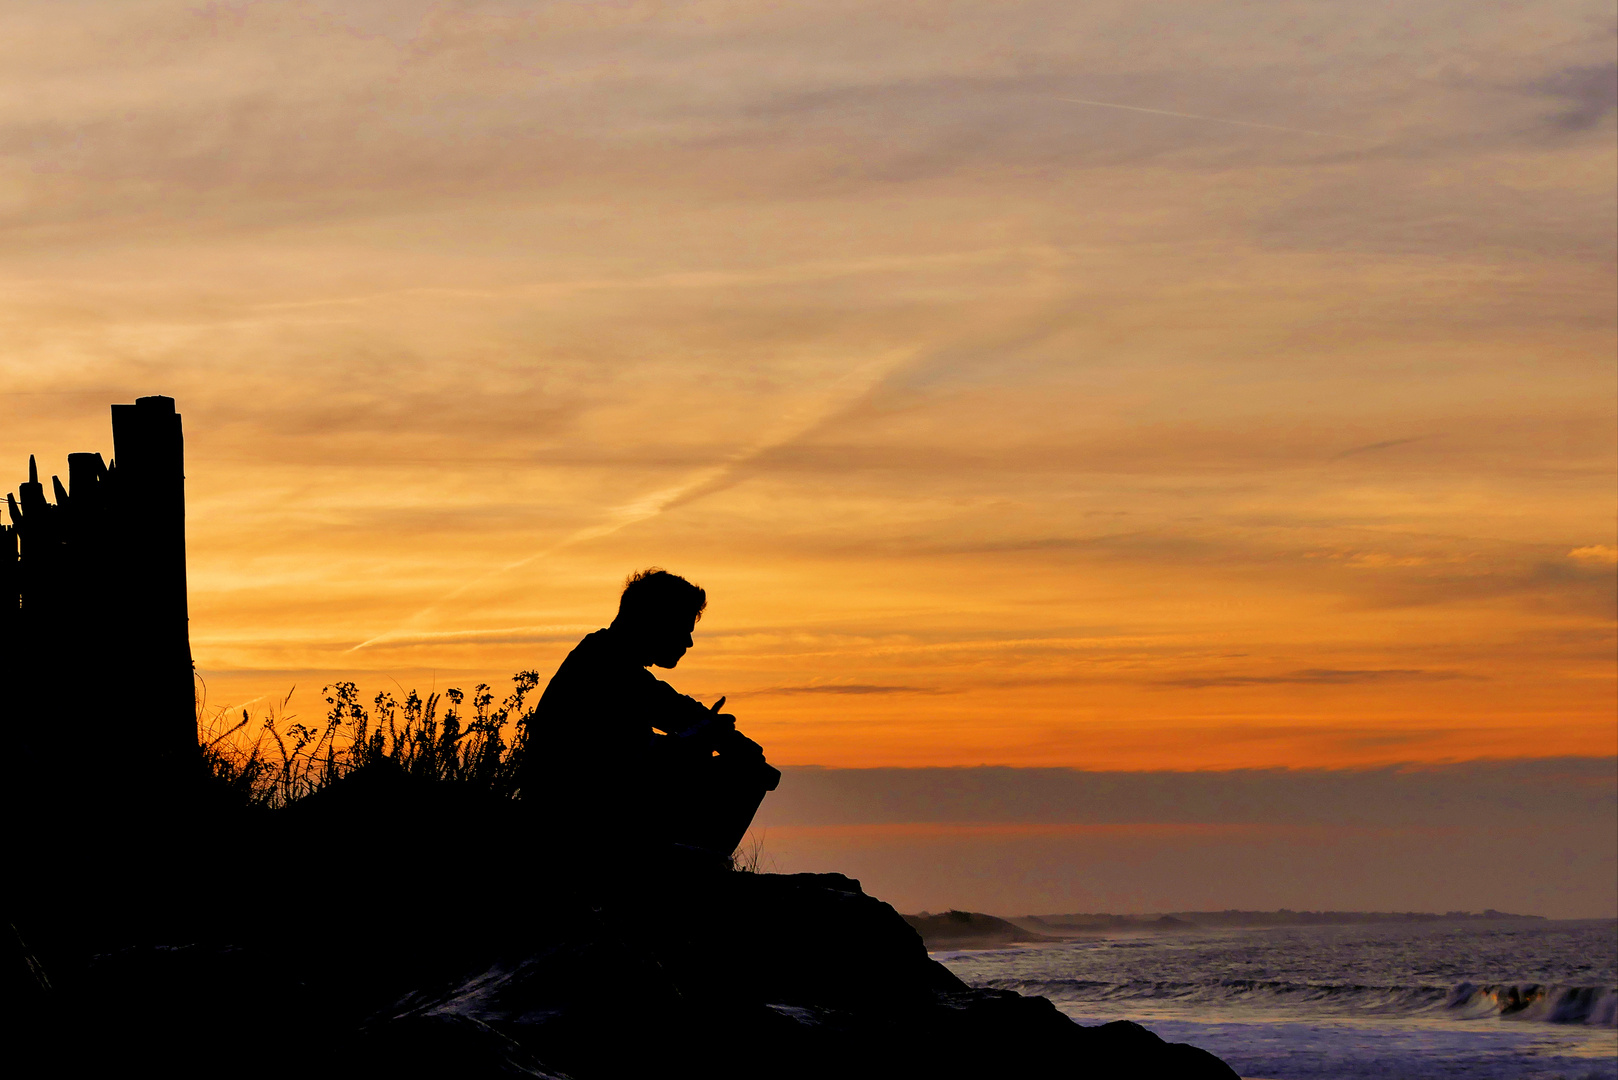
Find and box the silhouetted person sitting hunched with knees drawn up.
[521,568,781,870]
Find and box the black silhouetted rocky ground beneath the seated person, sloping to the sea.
[12,761,1236,1080]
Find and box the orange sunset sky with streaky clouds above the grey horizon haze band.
[0,0,1618,769]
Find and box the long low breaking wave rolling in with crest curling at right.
[981,978,1618,1028]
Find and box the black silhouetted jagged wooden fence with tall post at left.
[0,397,199,831]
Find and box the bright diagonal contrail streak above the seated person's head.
[348,348,914,653]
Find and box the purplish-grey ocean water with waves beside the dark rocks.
[934,920,1618,1080]
